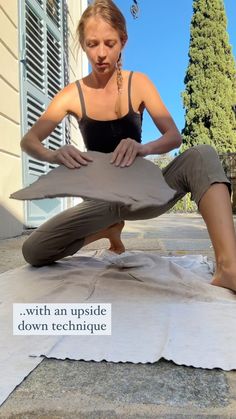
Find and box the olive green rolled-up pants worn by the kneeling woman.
[22,145,231,266]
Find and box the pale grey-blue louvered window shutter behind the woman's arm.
[19,0,70,227]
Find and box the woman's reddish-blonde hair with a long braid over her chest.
[76,0,128,118]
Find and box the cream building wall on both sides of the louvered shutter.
[0,0,88,239]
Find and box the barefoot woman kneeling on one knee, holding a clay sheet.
[21,0,236,291]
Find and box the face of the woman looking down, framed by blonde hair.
[83,17,123,74]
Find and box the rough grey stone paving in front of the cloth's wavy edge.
[0,359,236,418]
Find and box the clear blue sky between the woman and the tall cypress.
[115,0,236,151]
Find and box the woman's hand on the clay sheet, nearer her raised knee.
[110,138,146,167]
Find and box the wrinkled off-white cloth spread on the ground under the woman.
[0,251,236,403]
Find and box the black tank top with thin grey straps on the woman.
[76,71,143,153]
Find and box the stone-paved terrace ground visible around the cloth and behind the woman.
[0,214,236,419]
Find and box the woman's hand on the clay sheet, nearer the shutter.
[49,144,93,169]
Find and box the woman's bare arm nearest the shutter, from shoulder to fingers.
[20,85,92,169]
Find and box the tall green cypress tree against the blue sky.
[181,0,236,152]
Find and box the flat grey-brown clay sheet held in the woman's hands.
[10,151,175,210]
